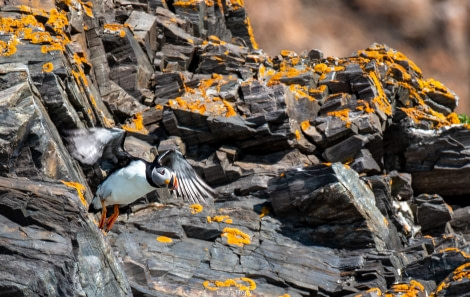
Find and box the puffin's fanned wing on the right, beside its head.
[158,150,217,205]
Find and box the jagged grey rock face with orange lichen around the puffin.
[0,0,470,296]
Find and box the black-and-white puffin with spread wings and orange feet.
[65,128,217,232]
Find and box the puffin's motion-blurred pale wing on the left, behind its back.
[65,128,126,165]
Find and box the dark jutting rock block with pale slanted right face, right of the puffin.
[268,163,399,250]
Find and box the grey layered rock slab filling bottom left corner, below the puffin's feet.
[0,177,132,296]
